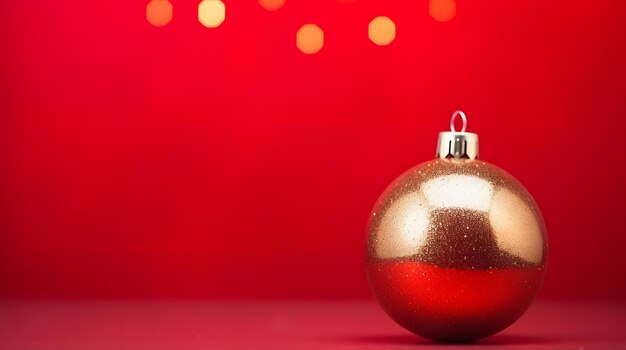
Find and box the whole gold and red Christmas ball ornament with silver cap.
[366,111,548,341]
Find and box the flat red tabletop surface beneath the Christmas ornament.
[0,301,626,350]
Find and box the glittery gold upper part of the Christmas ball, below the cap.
[367,159,547,269]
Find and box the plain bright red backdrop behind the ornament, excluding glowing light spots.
[0,0,626,298]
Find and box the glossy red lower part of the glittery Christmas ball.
[367,261,545,342]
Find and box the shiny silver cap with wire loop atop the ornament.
[437,110,478,159]
